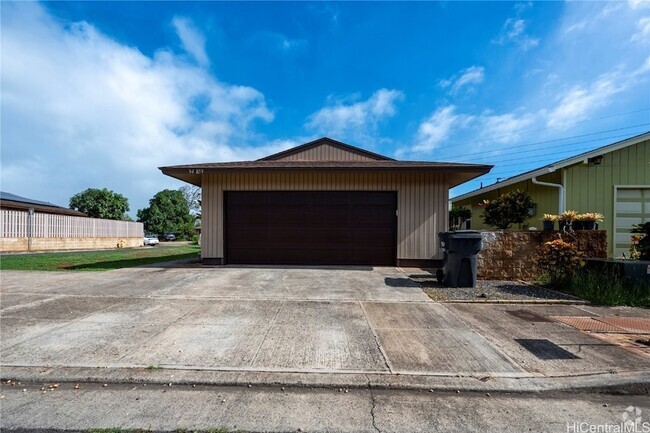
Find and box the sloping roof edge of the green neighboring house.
[451,131,650,202]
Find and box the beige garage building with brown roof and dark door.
[161,138,492,266]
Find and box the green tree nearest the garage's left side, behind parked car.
[138,189,195,239]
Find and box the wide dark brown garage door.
[225,191,397,265]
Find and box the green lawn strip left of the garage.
[0,245,200,271]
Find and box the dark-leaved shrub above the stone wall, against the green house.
[482,190,535,229]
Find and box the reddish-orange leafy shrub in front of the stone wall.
[538,239,585,284]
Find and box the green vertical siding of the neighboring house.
[454,140,650,256]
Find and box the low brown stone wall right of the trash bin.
[478,230,607,281]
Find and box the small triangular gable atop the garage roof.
[258,137,394,161]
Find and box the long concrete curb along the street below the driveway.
[0,366,650,395]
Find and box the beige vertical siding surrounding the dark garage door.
[201,171,448,259]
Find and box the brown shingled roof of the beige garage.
[160,138,492,186]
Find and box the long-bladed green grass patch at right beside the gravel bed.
[541,270,650,308]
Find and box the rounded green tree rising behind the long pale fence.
[70,188,129,220]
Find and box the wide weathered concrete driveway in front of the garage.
[0,267,650,386]
